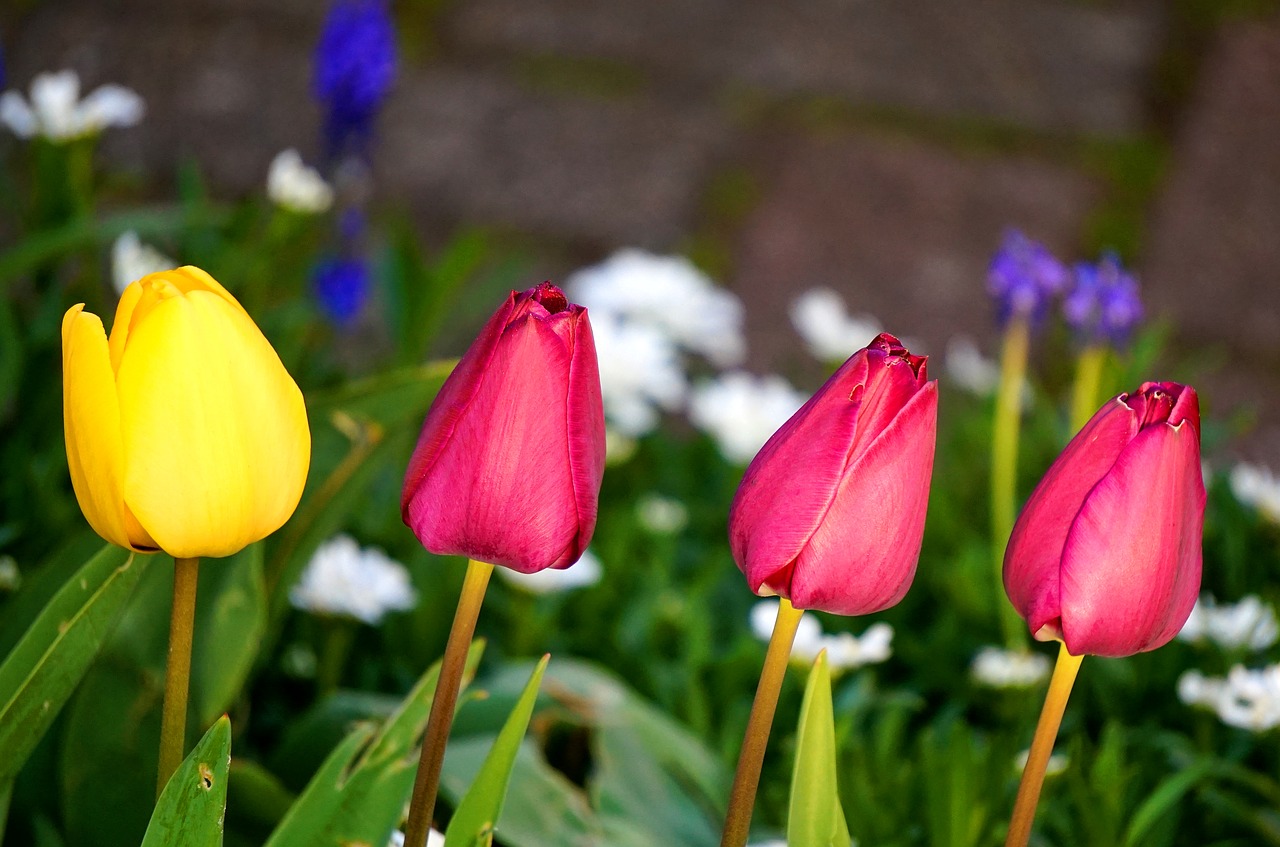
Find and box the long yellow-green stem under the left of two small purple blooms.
[991,317,1030,650]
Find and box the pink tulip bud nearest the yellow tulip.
[401,283,604,573]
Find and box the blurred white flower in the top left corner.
[0,70,145,141]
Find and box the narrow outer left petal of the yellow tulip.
[63,303,155,550]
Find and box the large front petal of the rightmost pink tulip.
[1061,424,1204,656]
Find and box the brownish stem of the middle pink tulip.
[721,598,804,847]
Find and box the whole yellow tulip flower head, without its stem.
[63,267,311,558]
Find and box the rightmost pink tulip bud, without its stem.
[1005,383,1204,656]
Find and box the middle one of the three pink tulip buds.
[728,334,938,614]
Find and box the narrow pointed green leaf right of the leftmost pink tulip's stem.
[444,655,550,847]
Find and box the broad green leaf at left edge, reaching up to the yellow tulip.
[0,545,150,784]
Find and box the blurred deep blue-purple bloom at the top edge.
[312,0,396,159]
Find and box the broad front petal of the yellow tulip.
[116,289,311,557]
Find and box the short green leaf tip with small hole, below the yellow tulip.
[142,715,232,847]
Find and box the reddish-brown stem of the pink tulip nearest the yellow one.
[404,559,493,847]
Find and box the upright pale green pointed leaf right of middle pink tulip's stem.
[787,650,850,847]
